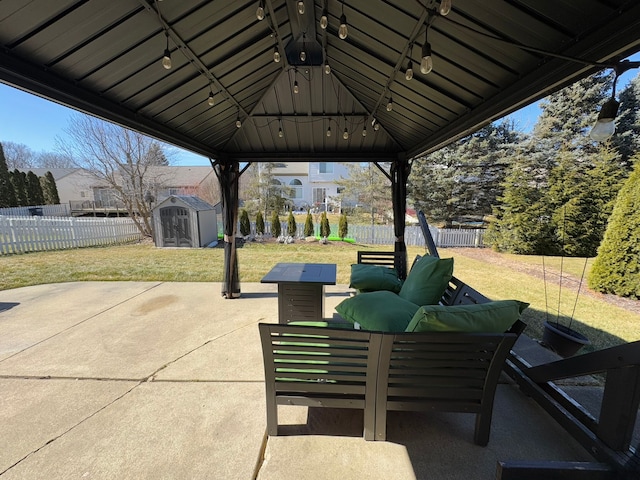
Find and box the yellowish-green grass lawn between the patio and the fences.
[0,242,640,350]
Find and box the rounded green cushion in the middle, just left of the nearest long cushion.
[336,290,419,332]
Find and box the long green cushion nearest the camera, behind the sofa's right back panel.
[405,300,529,333]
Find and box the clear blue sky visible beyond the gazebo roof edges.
[0,52,640,166]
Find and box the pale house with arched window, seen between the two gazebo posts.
[272,162,349,211]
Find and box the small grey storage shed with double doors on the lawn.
[153,195,218,247]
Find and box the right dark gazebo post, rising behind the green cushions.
[390,155,411,279]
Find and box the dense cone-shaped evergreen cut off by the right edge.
[588,154,640,299]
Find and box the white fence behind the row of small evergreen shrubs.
[238,222,484,247]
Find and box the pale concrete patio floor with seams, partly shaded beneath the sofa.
[0,282,593,480]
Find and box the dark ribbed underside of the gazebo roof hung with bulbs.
[0,0,640,161]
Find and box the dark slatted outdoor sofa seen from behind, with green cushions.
[259,253,527,445]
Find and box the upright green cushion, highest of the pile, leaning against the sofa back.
[398,256,453,305]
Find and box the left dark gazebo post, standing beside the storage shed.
[212,160,240,298]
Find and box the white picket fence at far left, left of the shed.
[0,215,142,255]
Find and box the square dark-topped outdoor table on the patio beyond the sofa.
[260,263,336,323]
